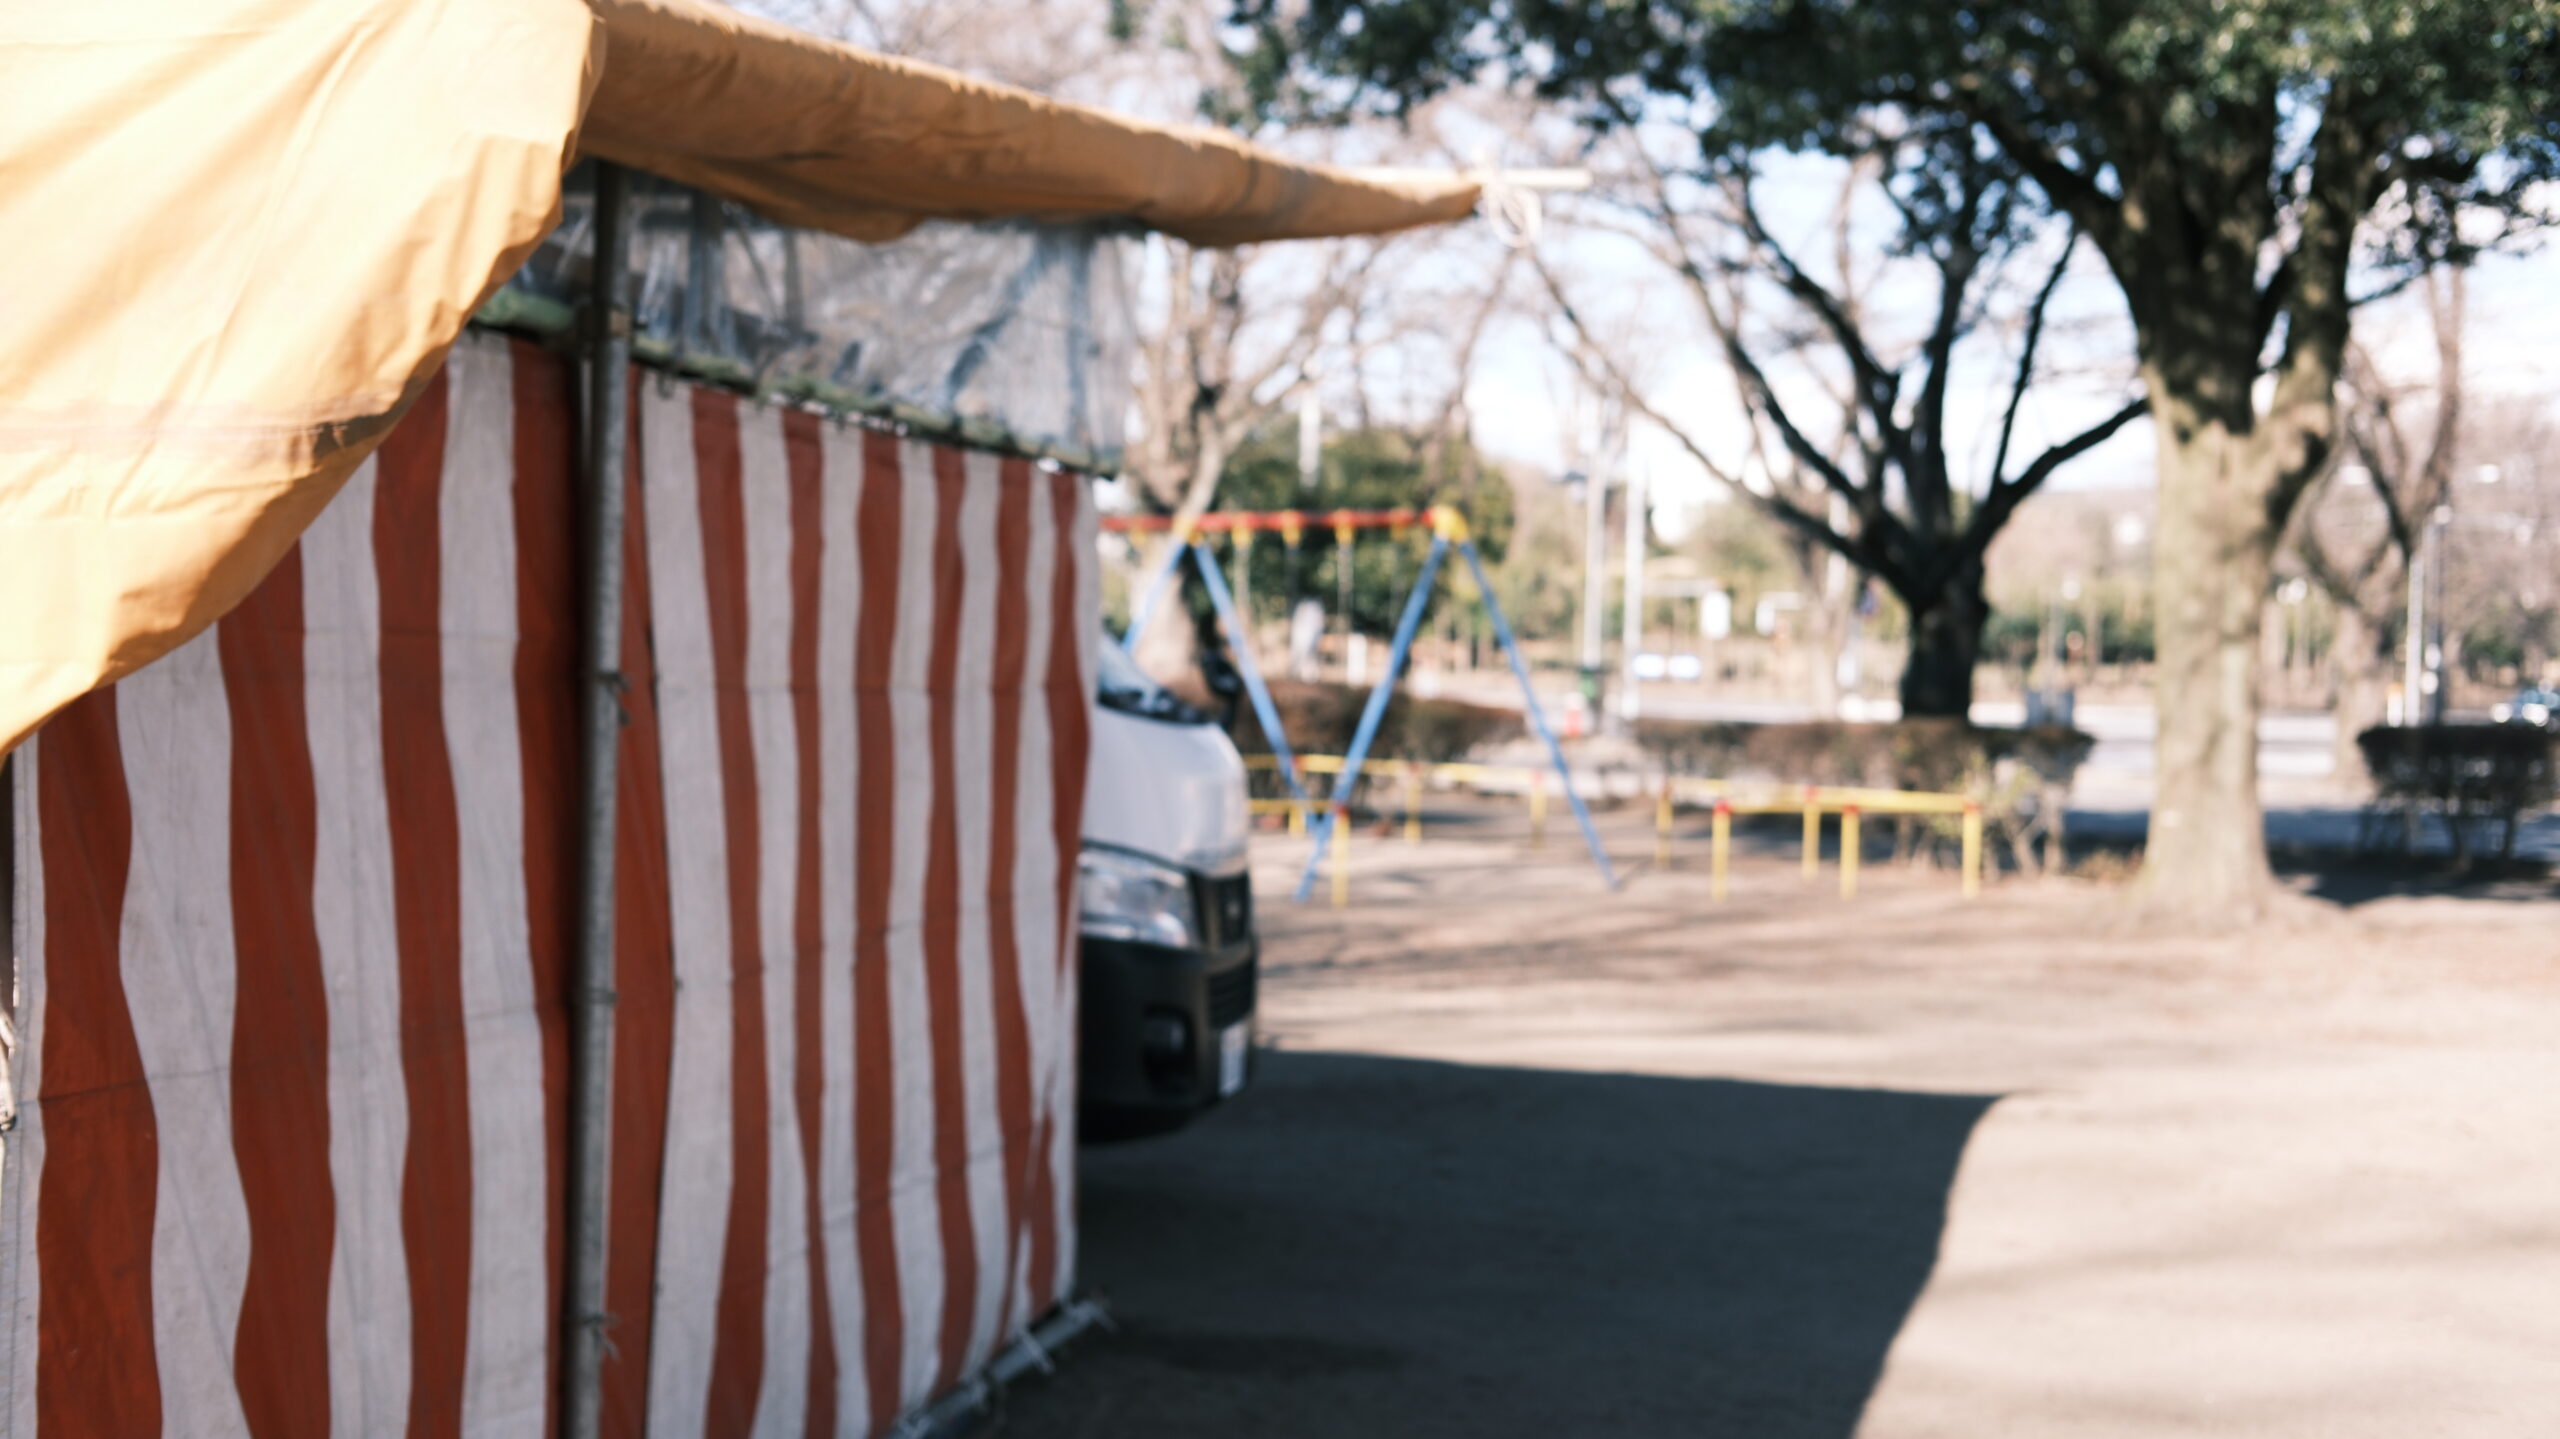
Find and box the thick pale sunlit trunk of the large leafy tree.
[2140,420,2278,927]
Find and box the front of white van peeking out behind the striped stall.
[1078,638,1260,1139]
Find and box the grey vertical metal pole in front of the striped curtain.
[561,164,632,1439]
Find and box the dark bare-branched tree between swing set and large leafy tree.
[1541,125,2148,717]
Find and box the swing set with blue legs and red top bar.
[1103,504,1618,901]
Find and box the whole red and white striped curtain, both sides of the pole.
[0,335,1096,1439]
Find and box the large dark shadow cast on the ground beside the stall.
[988,1052,1992,1439]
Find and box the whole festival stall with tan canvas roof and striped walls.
[0,0,1475,1436]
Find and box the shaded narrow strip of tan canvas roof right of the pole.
[581,0,1477,246]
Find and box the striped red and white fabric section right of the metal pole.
[617,387,1093,1436]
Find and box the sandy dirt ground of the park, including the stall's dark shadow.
[986,817,2560,1439]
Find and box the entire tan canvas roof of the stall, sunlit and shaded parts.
[0,0,1477,750]
